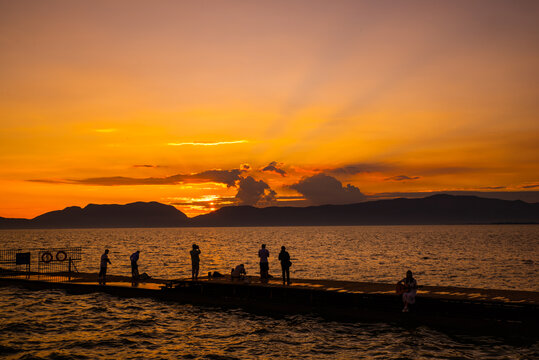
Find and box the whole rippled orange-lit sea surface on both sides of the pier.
[0,225,539,359]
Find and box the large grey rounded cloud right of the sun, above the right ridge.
[289,174,366,205]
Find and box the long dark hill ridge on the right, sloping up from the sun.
[190,195,539,226]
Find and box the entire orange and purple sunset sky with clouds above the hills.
[0,0,539,218]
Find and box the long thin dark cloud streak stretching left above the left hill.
[27,169,245,187]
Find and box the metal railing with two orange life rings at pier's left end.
[0,247,82,282]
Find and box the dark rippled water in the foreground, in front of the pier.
[0,288,539,359]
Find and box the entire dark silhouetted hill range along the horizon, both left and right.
[0,195,539,229]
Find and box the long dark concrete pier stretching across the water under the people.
[0,274,539,338]
